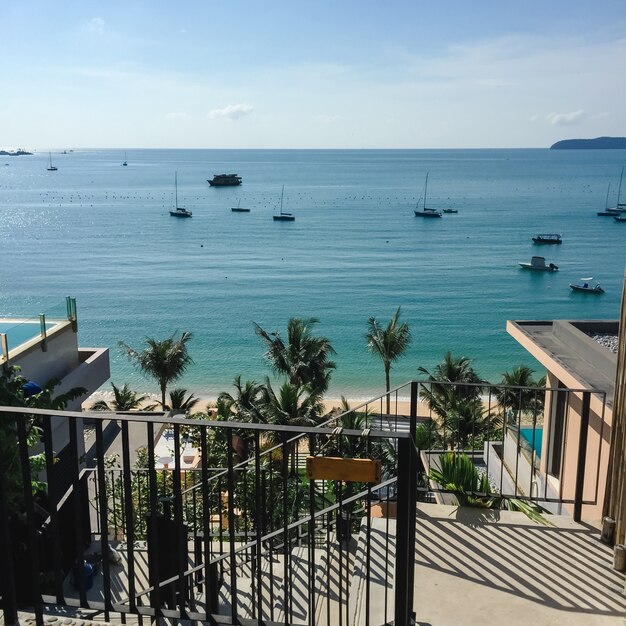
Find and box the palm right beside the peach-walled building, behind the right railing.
[496,365,545,424]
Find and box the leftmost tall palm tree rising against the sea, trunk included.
[119,332,193,406]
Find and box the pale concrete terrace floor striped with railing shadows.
[414,504,626,626]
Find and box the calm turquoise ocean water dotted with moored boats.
[0,149,626,398]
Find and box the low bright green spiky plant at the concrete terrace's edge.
[429,452,552,526]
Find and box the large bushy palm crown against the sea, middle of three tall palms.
[253,317,336,393]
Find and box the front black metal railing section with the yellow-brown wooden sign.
[0,398,417,625]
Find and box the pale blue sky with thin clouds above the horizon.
[0,0,626,150]
